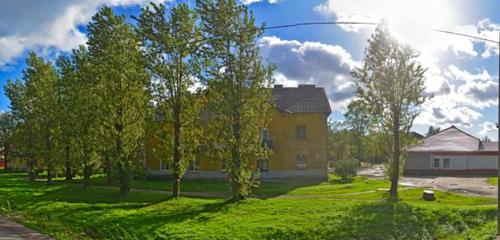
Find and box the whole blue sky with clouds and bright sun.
[0,0,500,140]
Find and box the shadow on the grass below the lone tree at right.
[266,200,496,239]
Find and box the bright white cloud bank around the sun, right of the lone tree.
[314,0,500,136]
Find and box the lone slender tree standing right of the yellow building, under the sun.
[352,25,425,199]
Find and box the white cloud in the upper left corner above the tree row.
[0,0,169,68]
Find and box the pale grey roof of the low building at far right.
[408,126,488,152]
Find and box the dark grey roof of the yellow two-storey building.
[272,84,332,114]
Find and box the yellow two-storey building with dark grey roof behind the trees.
[146,85,331,179]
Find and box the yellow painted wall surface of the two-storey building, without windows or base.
[146,109,328,171]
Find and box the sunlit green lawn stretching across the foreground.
[0,173,496,239]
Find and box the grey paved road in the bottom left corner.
[0,216,52,240]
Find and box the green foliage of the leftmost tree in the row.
[5,52,62,183]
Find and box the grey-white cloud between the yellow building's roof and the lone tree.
[259,37,359,111]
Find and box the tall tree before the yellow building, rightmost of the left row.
[197,0,273,200]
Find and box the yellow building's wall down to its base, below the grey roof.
[146,109,328,179]
